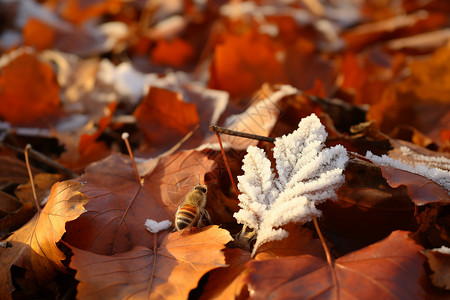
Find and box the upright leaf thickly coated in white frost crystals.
[234,114,348,253]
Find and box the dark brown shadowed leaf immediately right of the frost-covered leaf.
[319,158,418,253]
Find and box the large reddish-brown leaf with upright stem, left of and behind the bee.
[64,150,215,255]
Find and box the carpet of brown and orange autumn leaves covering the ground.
[0,0,450,299]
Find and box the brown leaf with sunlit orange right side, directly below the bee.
[70,226,231,299]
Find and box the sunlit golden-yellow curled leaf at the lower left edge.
[0,181,88,298]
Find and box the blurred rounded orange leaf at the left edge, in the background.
[0,52,62,127]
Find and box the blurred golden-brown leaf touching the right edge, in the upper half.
[368,45,450,145]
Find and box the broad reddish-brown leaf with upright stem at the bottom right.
[249,231,425,299]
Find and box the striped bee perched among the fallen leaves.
[175,184,211,231]
